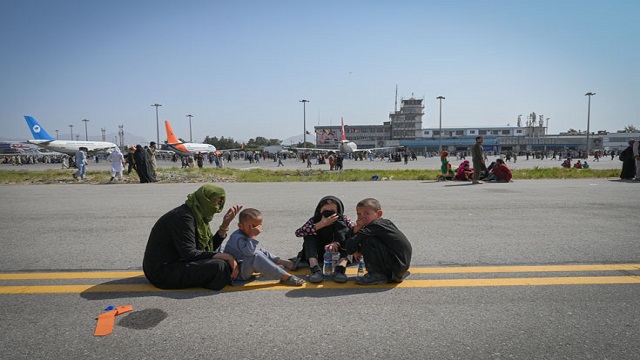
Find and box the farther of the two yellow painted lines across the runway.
[0,264,640,281]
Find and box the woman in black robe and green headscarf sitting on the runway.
[142,184,242,290]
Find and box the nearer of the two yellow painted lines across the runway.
[0,276,640,294]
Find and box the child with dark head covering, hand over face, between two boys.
[295,196,356,283]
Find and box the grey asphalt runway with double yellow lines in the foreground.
[0,179,640,359]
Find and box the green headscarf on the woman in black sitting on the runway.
[185,184,225,252]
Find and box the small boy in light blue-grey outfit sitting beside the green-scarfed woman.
[224,208,305,286]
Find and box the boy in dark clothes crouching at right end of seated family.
[346,198,412,285]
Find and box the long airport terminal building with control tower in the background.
[315,97,640,153]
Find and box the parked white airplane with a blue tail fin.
[24,115,118,155]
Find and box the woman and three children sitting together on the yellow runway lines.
[143,184,412,290]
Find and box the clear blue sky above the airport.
[0,0,640,141]
